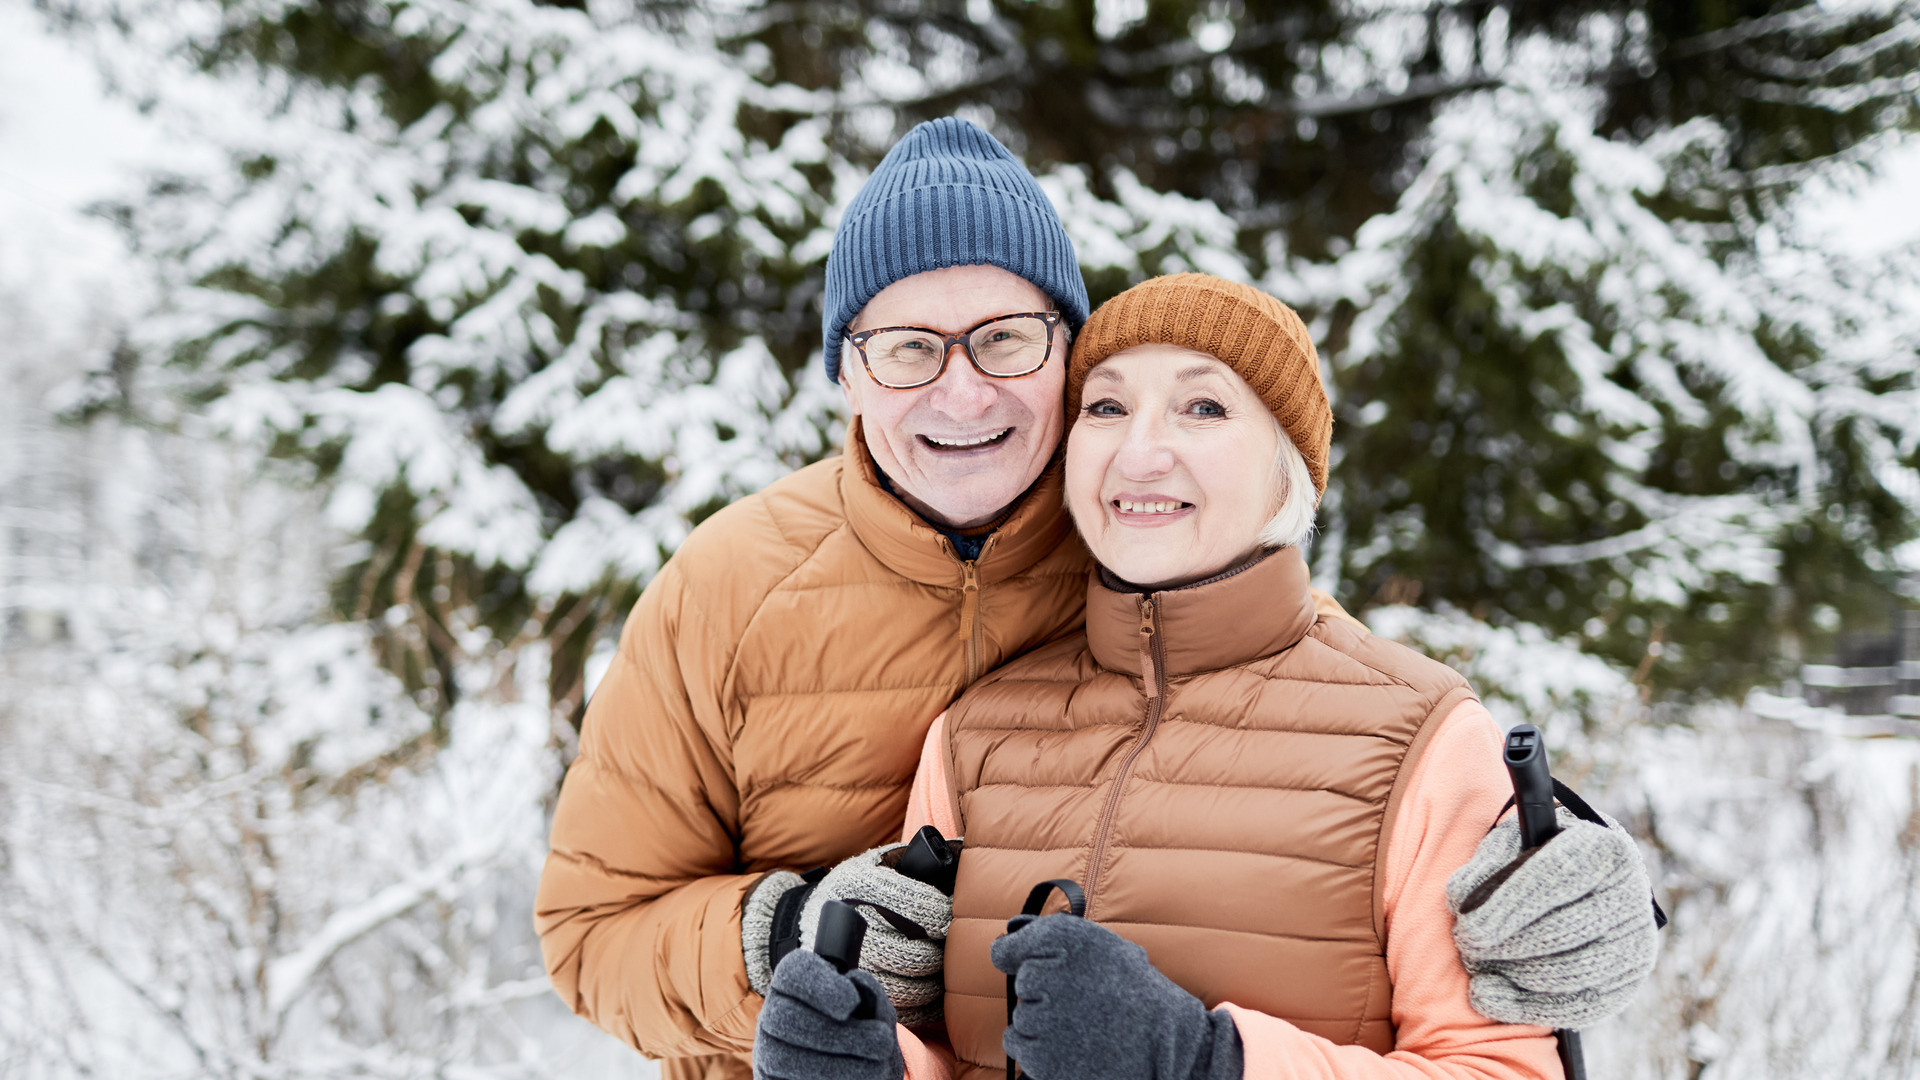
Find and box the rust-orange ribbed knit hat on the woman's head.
[1068,273,1332,494]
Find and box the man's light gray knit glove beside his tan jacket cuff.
[739,844,954,1026]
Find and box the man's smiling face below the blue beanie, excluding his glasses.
[841,265,1068,528]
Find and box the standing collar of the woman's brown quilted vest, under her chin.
[1087,548,1317,678]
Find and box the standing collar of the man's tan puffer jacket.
[841,417,1073,588]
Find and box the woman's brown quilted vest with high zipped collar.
[947,548,1473,1076]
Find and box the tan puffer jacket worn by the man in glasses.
[536,421,1344,1080]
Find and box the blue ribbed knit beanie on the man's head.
[820,117,1087,379]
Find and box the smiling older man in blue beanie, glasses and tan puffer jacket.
[536,119,1658,1078]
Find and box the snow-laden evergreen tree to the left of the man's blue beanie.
[37,0,847,713]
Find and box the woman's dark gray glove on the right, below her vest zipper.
[993,915,1242,1080]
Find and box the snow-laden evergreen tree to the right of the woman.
[1304,69,1920,694]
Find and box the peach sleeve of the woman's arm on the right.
[1225,701,1561,1080]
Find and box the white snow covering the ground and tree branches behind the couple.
[0,0,1920,1078]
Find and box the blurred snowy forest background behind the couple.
[0,0,1920,1080]
